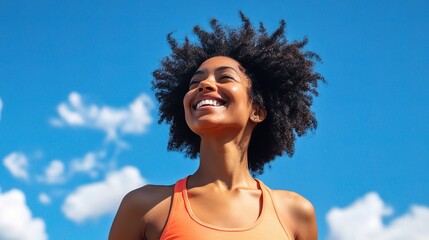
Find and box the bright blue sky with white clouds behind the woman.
[0,0,429,240]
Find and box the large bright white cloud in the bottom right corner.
[327,192,429,240]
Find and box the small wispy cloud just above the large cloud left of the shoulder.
[70,151,106,177]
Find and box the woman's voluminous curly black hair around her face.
[152,12,325,174]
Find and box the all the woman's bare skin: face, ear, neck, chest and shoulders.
[109,56,317,240]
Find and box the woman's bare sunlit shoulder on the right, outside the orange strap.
[272,190,317,240]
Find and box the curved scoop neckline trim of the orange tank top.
[182,176,267,232]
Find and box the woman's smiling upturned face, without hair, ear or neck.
[183,56,253,136]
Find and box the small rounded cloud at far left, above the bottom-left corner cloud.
[3,152,28,180]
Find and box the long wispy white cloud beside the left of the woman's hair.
[50,92,153,141]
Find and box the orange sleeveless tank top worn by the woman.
[160,177,291,240]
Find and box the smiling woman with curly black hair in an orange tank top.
[109,13,323,240]
